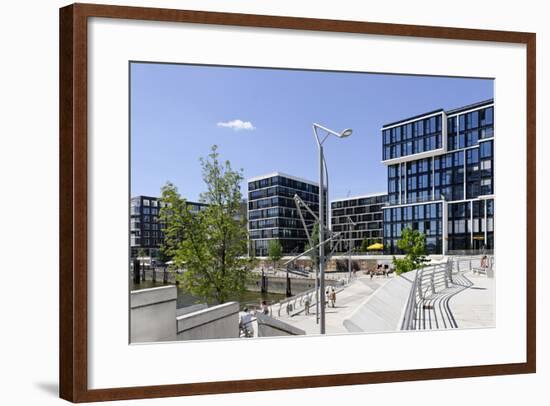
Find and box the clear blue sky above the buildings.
[130,63,493,200]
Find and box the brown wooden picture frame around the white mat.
[59,4,536,402]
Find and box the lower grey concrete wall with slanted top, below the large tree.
[176,302,239,340]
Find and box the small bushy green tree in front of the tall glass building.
[393,227,428,275]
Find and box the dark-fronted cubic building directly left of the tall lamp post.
[248,172,327,257]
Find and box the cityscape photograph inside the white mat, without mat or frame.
[128,61,496,344]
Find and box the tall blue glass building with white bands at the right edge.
[382,100,495,254]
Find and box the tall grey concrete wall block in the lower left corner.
[130,285,177,343]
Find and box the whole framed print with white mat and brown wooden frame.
[60,4,536,402]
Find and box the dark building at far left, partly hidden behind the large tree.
[130,196,207,258]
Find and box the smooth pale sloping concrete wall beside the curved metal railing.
[343,271,416,333]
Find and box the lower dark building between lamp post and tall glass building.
[331,193,388,252]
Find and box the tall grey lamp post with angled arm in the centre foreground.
[312,123,352,334]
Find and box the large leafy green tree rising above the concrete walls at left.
[160,145,253,303]
